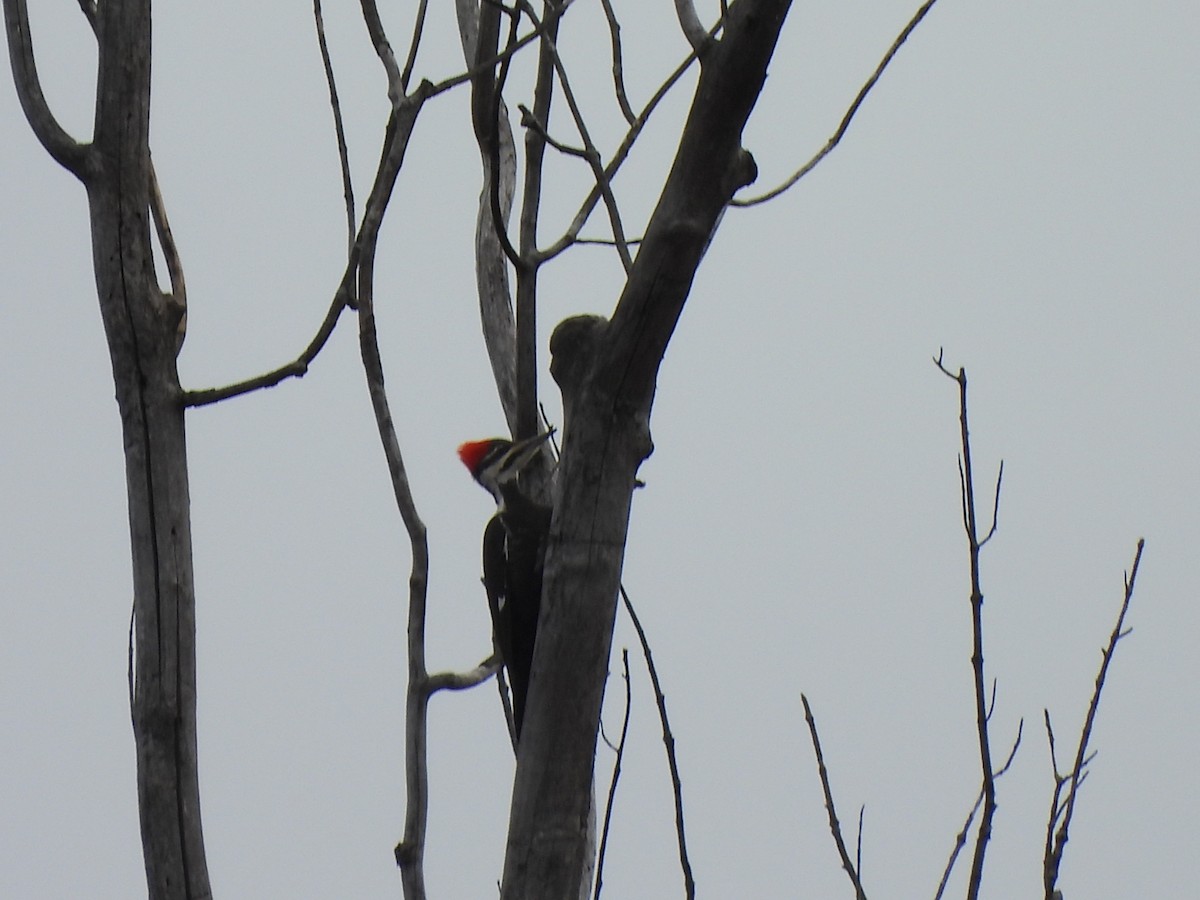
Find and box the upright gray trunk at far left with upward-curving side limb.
[5,0,211,900]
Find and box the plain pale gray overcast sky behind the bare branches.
[0,0,1200,900]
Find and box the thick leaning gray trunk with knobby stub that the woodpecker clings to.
[502,0,791,900]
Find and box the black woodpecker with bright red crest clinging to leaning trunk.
[458,430,553,739]
